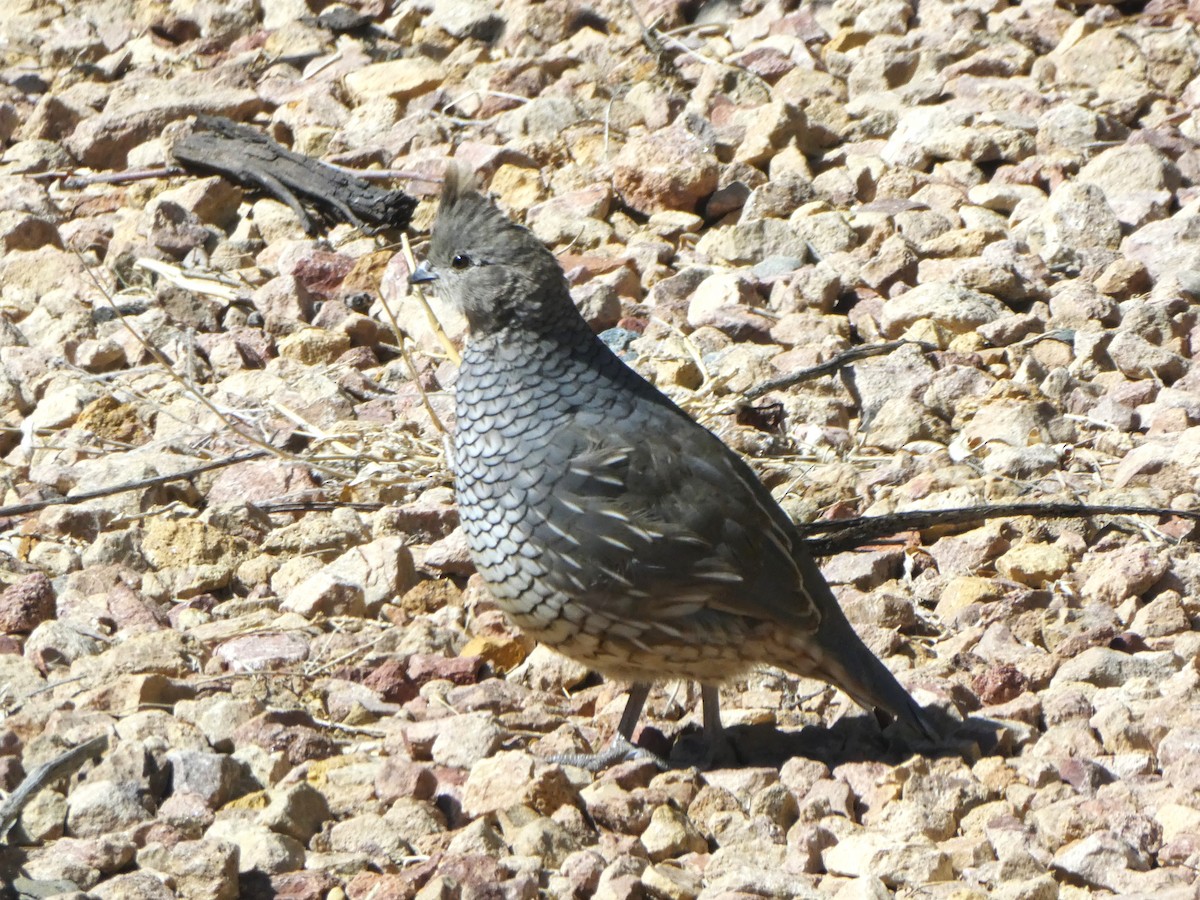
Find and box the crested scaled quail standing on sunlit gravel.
[412,167,934,763]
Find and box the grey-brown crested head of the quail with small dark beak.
[409,163,575,336]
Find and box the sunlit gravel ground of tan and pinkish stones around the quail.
[0,0,1200,900]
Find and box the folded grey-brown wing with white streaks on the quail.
[533,407,822,630]
